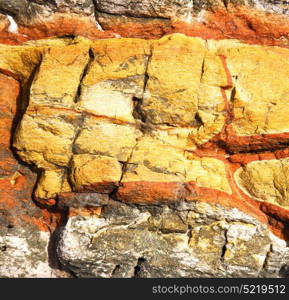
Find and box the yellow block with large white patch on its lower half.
[77,39,150,123]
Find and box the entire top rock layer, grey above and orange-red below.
[0,0,288,47]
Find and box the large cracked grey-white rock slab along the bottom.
[57,202,289,278]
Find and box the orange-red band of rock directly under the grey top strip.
[0,5,289,47]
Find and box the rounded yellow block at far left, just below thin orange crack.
[14,109,74,169]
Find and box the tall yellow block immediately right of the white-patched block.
[141,35,226,132]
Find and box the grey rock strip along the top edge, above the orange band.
[0,0,289,24]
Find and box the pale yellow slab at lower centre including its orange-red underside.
[117,137,231,203]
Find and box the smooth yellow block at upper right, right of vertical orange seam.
[218,45,289,136]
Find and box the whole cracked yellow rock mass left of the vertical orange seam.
[9,35,230,199]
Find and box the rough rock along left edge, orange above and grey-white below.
[0,74,67,278]
